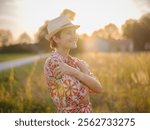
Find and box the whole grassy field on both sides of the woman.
[0,53,150,112]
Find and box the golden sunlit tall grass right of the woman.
[77,53,150,112]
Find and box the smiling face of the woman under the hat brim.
[57,28,78,49]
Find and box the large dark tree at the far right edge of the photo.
[122,13,150,51]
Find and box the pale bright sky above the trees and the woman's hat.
[0,0,150,38]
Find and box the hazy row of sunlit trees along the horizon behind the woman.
[0,9,150,52]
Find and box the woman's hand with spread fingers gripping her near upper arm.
[53,62,75,79]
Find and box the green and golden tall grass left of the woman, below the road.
[0,60,55,112]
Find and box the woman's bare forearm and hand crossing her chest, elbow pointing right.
[54,62,102,93]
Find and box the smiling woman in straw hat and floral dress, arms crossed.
[44,16,102,113]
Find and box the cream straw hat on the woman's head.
[45,15,80,40]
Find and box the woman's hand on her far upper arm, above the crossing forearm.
[77,60,90,74]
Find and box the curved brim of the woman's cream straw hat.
[45,25,80,41]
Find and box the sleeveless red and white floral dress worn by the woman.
[44,51,92,113]
